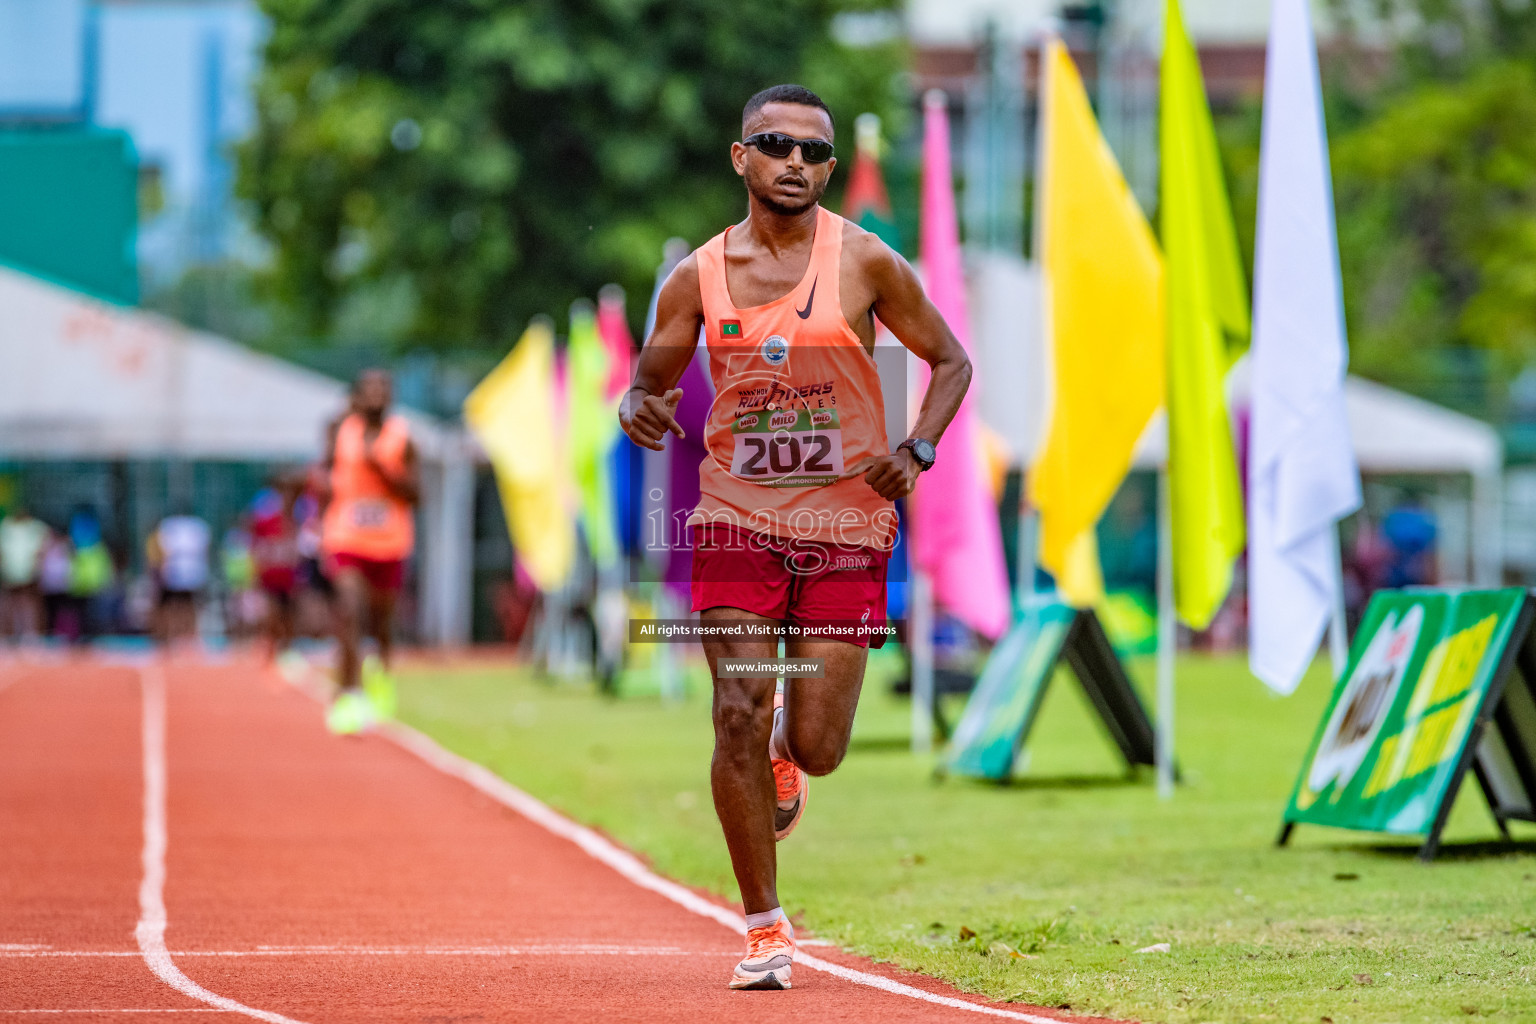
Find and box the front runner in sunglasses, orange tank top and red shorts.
[619,86,971,989]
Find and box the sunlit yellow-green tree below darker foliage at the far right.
[1335,60,1536,376]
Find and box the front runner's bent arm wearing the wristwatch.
[843,235,971,500]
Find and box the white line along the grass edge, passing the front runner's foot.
[378,722,1063,1024]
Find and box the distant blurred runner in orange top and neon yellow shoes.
[321,370,421,734]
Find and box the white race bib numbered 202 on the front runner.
[731,408,843,487]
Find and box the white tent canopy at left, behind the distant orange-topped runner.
[0,267,473,642]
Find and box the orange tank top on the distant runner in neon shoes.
[321,413,416,562]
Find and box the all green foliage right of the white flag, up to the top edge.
[1329,0,1536,396]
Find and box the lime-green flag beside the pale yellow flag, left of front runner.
[565,301,619,567]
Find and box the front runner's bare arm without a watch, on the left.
[619,255,703,451]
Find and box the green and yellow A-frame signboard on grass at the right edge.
[1281,588,1536,857]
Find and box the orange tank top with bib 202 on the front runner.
[688,209,895,550]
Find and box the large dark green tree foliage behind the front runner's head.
[238,0,903,345]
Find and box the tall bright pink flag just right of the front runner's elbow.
[911,89,1009,639]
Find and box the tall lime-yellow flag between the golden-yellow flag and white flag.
[1158,0,1249,629]
